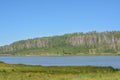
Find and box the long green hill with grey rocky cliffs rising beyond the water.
[0,31,120,55]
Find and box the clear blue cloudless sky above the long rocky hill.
[0,0,120,46]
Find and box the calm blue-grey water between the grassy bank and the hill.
[0,56,120,68]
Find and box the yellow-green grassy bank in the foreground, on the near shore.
[0,62,120,80]
